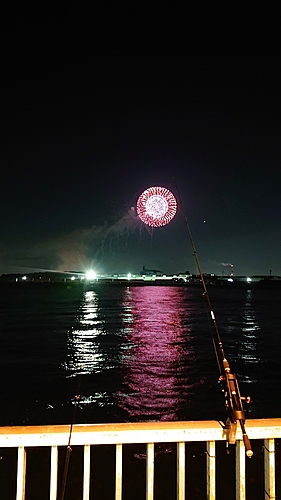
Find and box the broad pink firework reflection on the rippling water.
[118,286,196,420]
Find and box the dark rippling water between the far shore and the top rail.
[0,283,281,425]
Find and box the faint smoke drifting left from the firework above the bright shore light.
[0,207,142,272]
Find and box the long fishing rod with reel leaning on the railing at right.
[176,186,253,458]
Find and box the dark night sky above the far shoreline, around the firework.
[0,1,281,275]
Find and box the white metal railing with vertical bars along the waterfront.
[0,418,281,500]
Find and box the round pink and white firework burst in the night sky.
[137,186,177,227]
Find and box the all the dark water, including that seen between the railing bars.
[0,283,281,500]
